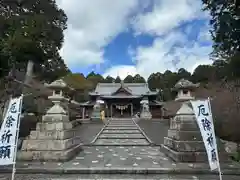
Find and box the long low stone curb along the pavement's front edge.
[0,167,240,176]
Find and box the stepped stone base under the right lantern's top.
[162,102,227,162]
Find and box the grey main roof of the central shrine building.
[89,83,158,96]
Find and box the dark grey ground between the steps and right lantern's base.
[138,120,169,145]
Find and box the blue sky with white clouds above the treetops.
[57,0,212,79]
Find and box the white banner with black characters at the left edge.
[0,96,22,165]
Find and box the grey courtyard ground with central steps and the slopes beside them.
[0,118,240,180]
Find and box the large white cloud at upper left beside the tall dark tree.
[57,0,138,68]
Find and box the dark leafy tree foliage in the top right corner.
[202,0,240,58]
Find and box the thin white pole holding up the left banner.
[11,94,23,180]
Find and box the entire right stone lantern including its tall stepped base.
[161,79,228,163]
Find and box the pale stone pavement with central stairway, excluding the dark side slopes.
[0,119,240,180]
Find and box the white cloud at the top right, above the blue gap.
[133,0,206,35]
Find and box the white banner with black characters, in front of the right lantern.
[191,100,219,170]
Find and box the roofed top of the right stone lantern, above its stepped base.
[173,79,199,101]
